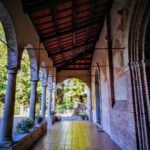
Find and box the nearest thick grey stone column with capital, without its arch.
[1,67,17,145]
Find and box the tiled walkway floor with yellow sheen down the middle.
[32,121,120,150]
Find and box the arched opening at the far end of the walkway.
[56,78,89,119]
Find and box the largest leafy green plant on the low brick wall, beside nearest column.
[16,118,34,134]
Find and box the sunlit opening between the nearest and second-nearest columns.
[15,49,31,117]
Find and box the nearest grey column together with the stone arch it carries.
[0,2,18,145]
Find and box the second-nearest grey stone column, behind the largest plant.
[29,80,38,120]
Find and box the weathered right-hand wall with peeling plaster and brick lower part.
[91,0,136,150]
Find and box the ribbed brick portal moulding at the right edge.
[129,0,150,149]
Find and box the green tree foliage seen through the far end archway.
[56,78,87,109]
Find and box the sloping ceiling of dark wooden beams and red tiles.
[22,0,112,71]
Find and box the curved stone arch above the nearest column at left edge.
[0,2,18,68]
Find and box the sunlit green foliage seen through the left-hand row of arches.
[0,23,41,114]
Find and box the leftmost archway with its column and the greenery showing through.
[0,2,18,143]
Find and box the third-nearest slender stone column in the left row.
[41,84,47,118]
